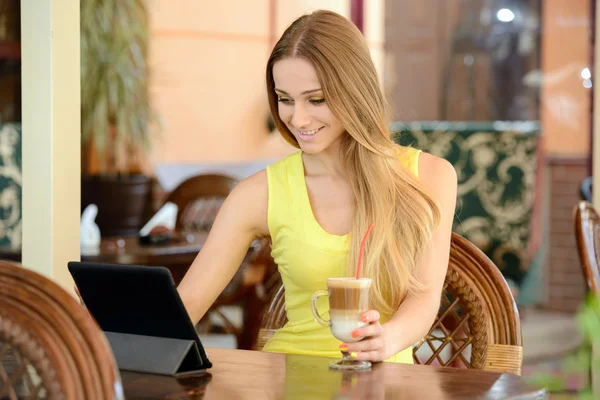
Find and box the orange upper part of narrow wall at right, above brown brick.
[541,0,591,156]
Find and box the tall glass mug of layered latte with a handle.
[310,278,371,369]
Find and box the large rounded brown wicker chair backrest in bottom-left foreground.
[0,261,123,400]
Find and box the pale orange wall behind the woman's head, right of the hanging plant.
[149,0,383,163]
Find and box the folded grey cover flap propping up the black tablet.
[104,331,206,376]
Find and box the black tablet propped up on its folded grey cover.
[69,262,212,377]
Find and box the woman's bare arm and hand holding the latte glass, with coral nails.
[348,153,457,361]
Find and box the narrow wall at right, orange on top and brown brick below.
[540,0,592,312]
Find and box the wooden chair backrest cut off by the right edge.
[575,201,600,293]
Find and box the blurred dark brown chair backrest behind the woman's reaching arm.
[165,174,238,231]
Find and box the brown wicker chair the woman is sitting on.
[255,233,523,375]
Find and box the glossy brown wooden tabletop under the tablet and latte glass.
[121,348,547,400]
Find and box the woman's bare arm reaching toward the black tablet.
[177,171,268,324]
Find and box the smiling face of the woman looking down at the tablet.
[273,58,345,154]
